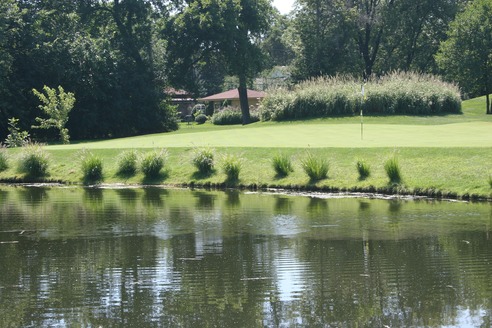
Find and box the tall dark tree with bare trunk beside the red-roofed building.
[168,0,272,124]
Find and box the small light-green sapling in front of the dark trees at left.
[32,85,75,144]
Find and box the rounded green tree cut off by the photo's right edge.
[436,0,492,114]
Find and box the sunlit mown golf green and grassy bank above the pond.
[0,99,492,199]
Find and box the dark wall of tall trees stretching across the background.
[0,0,480,140]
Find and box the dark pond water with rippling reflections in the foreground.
[0,186,492,327]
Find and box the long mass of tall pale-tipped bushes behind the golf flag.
[260,72,461,121]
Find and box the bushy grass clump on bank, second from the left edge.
[18,143,49,178]
